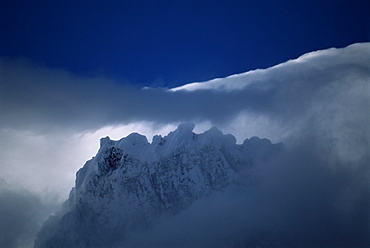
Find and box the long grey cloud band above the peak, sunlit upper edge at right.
[0,43,370,139]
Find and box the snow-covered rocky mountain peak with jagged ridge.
[35,124,283,248]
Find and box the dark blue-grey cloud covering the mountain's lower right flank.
[126,140,370,247]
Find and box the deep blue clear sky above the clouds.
[0,0,370,87]
